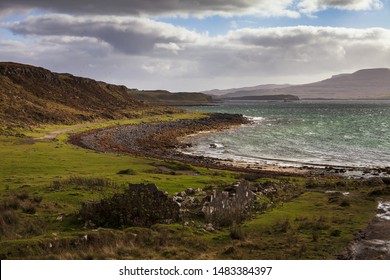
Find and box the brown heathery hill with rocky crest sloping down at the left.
[0,62,173,129]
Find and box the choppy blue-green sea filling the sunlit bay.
[179,100,390,168]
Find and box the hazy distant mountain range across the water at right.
[204,68,390,99]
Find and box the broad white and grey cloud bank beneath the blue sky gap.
[0,15,390,90]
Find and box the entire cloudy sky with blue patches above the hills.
[0,0,390,91]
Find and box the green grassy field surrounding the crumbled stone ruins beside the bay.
[0,114,383,259]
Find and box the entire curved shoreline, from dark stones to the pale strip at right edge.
[69,113,390,178]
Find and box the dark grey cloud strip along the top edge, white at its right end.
[0,0,297,16]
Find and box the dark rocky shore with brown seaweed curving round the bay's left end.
[69,113,302,175]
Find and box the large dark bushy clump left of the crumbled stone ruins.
[80,184,180,227]
